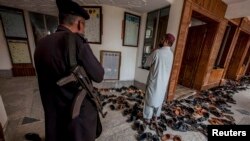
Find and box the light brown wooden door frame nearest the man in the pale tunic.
[166,0,227,101]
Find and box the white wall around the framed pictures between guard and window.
[89,5,141,80]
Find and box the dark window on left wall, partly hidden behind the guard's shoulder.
[29,12,58,44]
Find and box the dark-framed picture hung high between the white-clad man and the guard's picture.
[123,12,141,47]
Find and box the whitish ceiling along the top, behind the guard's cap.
[0,0,171,15]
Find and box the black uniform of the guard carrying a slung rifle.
[34,26,104,141]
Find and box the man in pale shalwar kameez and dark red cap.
[143,34,175,123]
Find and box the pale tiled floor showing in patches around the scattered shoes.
[0,77,250,141]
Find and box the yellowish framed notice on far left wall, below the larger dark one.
[7,39,31,64]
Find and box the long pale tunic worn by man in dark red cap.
[145,46,173,107]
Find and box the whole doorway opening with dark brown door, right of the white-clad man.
[178,12,218,90]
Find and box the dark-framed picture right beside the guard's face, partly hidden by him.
[83,6,102,44]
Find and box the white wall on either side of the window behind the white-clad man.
[135,0,184,83]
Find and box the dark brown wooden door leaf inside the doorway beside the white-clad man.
[179,25,207,88]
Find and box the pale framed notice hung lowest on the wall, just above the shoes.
[100,50,121,80]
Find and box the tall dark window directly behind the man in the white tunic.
[142,7,170,69]
